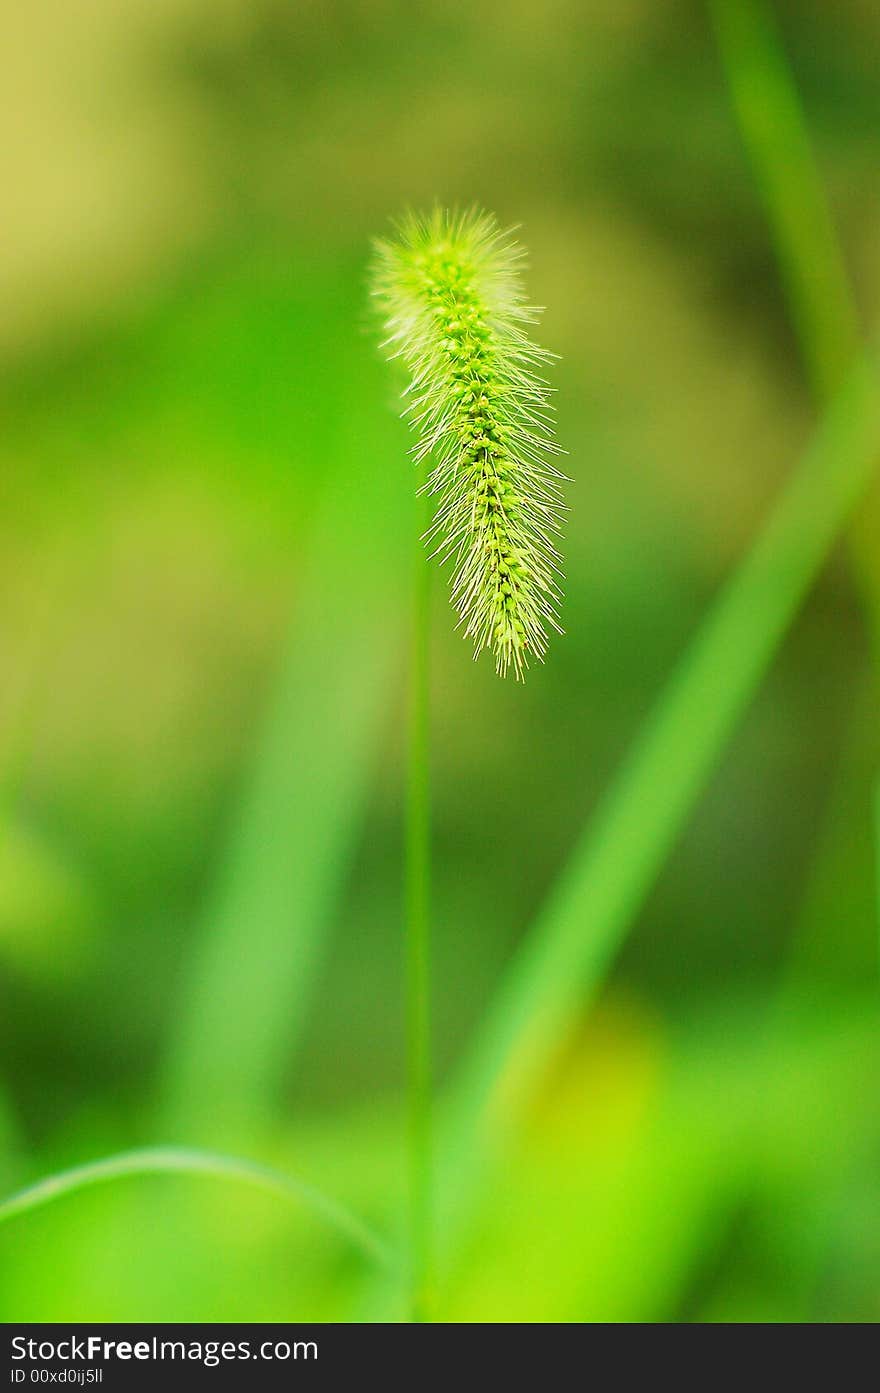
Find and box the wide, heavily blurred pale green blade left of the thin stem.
[159,415,408,1145]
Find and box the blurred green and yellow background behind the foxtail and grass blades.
[0,0,880,1322]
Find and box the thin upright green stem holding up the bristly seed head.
[405,472,433,1321]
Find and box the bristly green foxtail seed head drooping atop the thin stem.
[372,209,564,677]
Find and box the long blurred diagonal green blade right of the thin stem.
[441,359,880,1236]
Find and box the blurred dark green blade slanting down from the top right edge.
[710,0,861,401]
